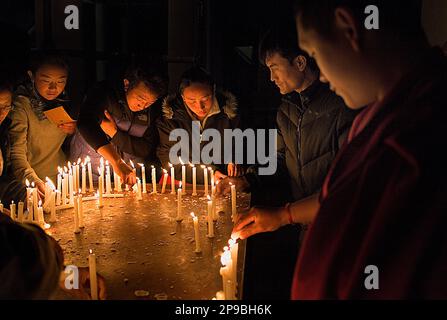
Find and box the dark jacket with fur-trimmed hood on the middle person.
[157,90,240,183]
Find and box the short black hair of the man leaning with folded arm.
[124,64,168,96]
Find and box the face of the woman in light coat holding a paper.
[28,65,68,100]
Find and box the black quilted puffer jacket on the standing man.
[247,80,357,201]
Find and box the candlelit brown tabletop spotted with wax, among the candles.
[47,185,250,300]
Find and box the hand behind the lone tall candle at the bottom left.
[59,267,107,300]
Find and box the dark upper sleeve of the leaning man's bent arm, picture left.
[78,86,110,151]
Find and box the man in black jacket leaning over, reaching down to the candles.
[75,66,167,185]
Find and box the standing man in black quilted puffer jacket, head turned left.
[218,24,355,299]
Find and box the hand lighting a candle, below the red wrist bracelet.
[231,207,288,239]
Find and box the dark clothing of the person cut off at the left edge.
[0,118,26,208]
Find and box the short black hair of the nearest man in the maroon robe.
[294,0,423,39]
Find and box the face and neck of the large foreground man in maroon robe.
[296,9,377,109]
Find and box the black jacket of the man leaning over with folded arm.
[78,82,163,161]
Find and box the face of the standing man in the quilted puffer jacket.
[265,52,304,94]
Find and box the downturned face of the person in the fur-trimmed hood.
[182,83,214,120]
